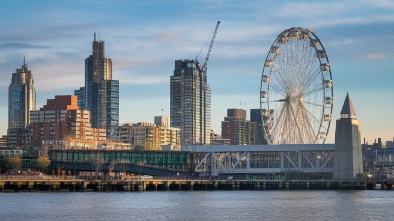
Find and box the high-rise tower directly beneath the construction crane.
[170,59,211,146]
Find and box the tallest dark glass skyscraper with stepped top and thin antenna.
[78,33,119,137]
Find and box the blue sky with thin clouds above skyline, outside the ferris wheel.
[0,0,394,144]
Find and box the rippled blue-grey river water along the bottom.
[0,190,394,221]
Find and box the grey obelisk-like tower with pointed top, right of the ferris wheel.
[333,94,363,179]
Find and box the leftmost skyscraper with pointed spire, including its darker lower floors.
[7,59,36,147]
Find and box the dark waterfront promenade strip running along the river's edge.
[0,175,394,192]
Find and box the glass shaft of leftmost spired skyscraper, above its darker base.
[8,59,36,129]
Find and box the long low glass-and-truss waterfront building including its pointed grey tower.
[49,95,363,180]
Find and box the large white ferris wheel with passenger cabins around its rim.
[260,28,334,144]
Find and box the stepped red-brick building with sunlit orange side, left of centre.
[30,95,127,155]
